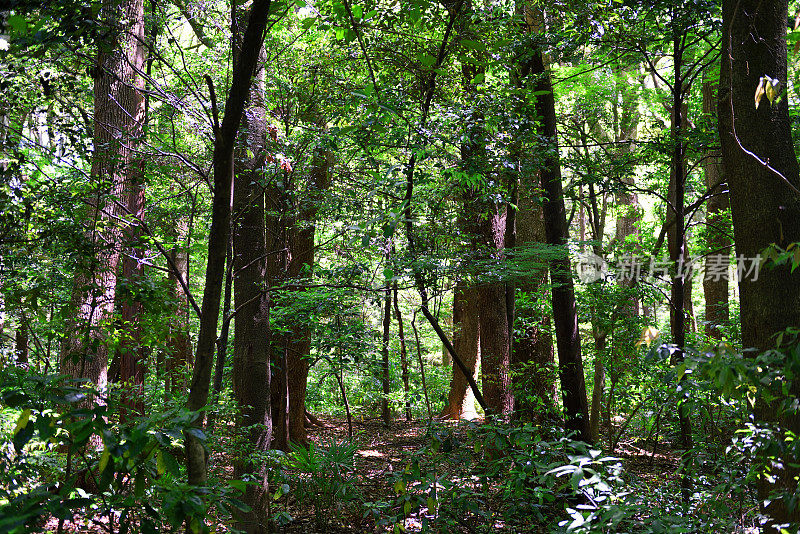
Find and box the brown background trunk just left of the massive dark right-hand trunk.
[703,81,731,339]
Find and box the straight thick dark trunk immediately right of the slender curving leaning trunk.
[232,13,272,533]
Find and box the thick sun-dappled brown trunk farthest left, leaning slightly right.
[61,0,145,412]
